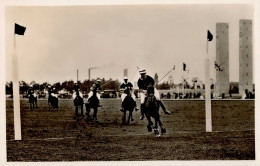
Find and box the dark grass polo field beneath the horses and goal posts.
[6,99,255,161]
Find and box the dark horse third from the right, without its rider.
[85,89,99,122]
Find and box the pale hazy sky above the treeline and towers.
[5,4,254,83]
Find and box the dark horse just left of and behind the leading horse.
[122,88,135,124]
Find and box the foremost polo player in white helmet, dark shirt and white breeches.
[137,69,170,120]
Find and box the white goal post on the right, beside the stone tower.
[205,40,212,132]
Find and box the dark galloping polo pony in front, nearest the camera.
[144,86,166,137]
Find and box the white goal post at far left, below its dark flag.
[12,34,22,140]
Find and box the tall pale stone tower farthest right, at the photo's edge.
[239,20,253,94]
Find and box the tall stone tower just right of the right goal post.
[216,23,229,96]
